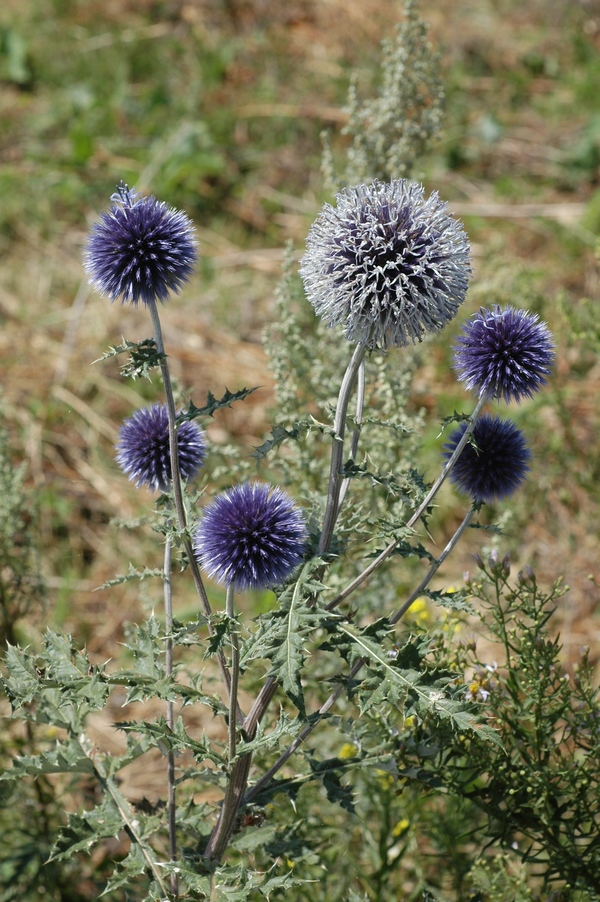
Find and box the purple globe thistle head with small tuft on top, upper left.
[84,184,198,305]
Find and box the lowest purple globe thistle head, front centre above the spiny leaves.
[194,482,307,590]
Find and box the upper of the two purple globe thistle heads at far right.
[454,305,555,404]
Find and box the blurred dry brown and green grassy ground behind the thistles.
[0,0,600,898]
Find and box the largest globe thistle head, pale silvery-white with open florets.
[300,179,471,348]
